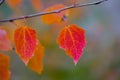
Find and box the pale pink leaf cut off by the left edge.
[0,29,12,51]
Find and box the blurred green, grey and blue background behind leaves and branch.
[0,0,120,80]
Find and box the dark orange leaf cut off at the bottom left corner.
[0,53,10,80]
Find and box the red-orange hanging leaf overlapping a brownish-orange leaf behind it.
[14,26,38,64]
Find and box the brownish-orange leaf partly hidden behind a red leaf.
[27,43,44,74]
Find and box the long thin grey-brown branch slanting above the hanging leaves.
[0,0,108,22]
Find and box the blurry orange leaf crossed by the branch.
[41,4,68,24]
